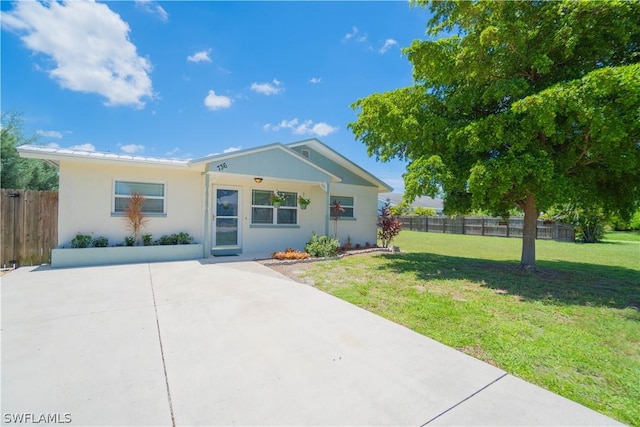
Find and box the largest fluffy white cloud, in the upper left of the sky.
[0,1,154,108]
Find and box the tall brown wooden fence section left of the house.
[0,188,58,268]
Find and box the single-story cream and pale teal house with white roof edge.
[18,139,392,266]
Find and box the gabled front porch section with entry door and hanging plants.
[195,144,340,258]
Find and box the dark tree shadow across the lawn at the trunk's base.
[379,253,640,312]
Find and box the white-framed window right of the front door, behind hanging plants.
[251,190,298,225]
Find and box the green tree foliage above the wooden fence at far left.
[0,113,58,190]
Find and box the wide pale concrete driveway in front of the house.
[2,261,616,426]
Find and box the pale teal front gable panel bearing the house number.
[207,146,332,182]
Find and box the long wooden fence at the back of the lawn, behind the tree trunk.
[398,216,576,242]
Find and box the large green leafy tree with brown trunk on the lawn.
[349,0,640,267]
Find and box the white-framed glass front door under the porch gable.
[212,187,241,255]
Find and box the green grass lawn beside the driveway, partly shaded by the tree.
[307,231,640,425]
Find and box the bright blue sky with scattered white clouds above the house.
[1,1,436,191]
